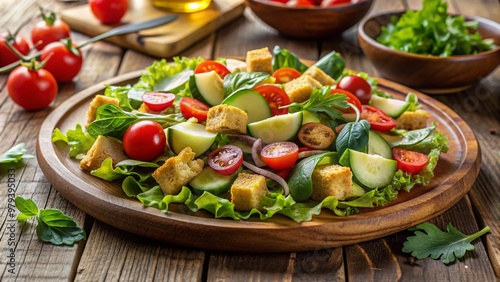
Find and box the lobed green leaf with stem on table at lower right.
[403,222,491,264]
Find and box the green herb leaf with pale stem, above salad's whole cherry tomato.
[87,104,185,139]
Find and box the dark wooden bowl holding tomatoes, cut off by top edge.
[246,0,373,39]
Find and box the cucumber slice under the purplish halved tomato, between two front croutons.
[189,166,238,196]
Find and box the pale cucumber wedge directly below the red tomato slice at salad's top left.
[190,71,224,106]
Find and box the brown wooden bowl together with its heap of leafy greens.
[358,0,500,93]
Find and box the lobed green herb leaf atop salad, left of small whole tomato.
[283,86,349,120]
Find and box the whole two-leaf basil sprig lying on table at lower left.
[14,197,87,246]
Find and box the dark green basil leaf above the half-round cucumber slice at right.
[335,120,370,156]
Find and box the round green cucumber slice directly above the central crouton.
[221,89,272,123]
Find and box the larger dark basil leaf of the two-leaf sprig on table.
[36,209,87,246]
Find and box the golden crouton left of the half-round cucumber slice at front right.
[311,164,353,202]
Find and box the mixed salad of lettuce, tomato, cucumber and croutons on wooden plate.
[52,46,449,222]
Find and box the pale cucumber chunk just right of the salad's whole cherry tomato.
[165,121,217,157]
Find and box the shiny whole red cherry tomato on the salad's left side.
[122,120,167,162]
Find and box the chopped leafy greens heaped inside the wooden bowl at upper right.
[377,0,496,57]
